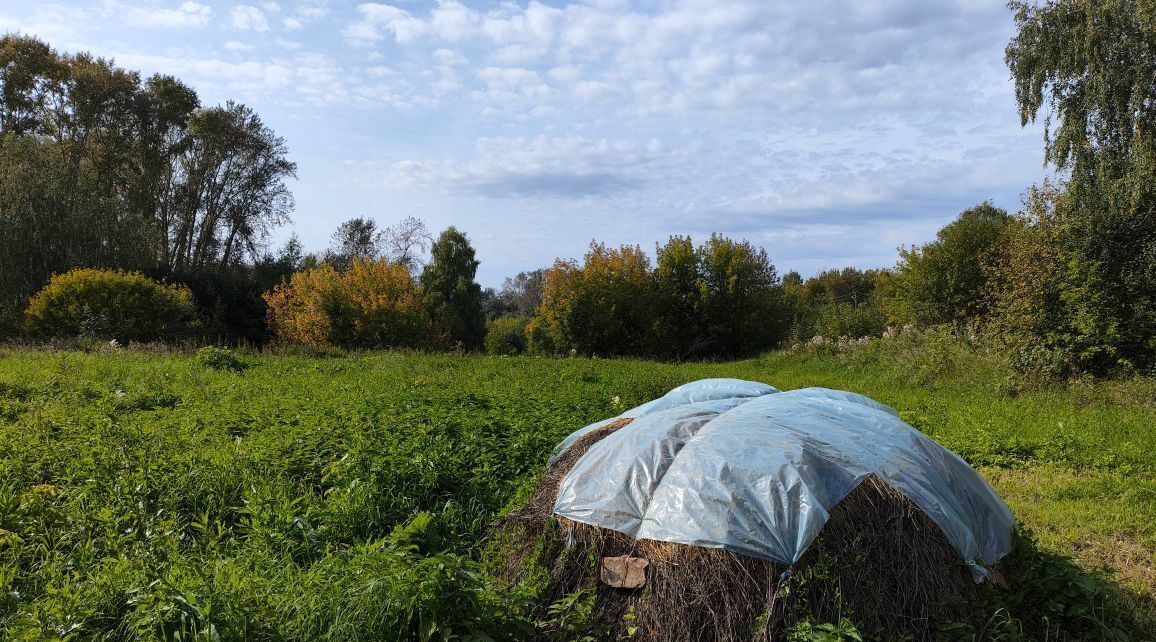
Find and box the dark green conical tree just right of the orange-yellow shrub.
[421,227,486,349]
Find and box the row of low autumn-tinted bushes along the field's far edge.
[24,195,1156,378]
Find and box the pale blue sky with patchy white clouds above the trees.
[0,0,1048,286]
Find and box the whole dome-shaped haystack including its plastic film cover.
[503,379,1014,641]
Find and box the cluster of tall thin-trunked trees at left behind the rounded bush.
[0,35,296,338]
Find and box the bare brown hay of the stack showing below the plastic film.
[498,419,991,642]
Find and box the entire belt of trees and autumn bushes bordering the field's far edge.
[0,0,1156,377]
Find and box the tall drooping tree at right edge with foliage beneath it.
[998,0,1156,371]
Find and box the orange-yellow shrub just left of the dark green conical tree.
[265,259,431,348]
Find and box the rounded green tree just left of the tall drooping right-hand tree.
[888,202,1010,326]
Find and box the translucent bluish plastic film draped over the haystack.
[554,379,1014,578]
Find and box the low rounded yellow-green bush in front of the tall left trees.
[24,268,195,341]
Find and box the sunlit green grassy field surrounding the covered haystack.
[0,334,1156,641]
